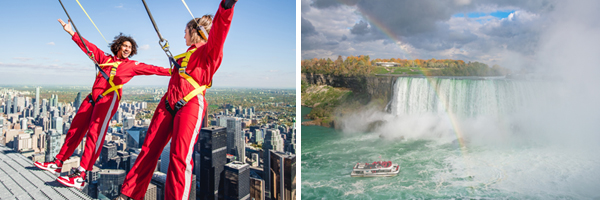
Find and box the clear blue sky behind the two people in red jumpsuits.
[0,0,296,88]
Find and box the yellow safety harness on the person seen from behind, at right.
[165,48,212,116]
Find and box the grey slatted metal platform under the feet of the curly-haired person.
[0,145,92,199]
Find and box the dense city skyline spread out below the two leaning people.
[0,87,296,199]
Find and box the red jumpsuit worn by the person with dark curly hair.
[56,33,169,171]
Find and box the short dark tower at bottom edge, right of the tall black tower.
[223,161,250,200]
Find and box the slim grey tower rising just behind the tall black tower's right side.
[227,117,246,162]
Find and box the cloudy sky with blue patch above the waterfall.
[301,0,600,69]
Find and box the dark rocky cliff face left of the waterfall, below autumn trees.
[302,73,398,102]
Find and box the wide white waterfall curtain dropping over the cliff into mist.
[390,77,542,118]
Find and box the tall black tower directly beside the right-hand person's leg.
[199,126,227,200]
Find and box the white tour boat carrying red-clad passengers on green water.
[350,161,400,177]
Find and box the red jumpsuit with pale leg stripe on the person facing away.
[121,0,233,200]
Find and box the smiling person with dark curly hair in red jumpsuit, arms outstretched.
[34,19,169,189]
